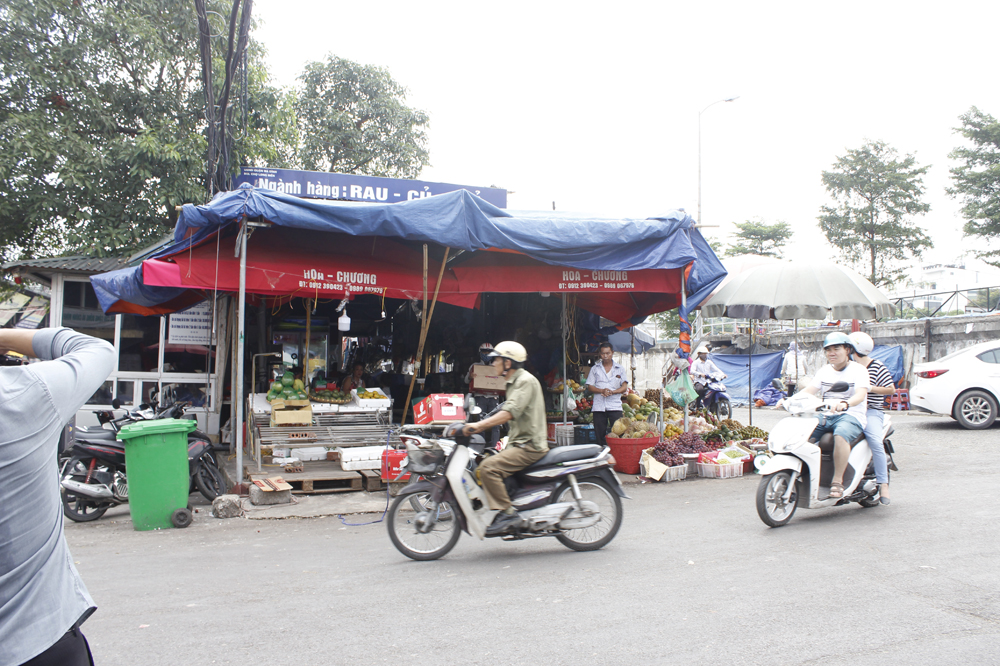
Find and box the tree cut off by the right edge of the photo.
[948,107,1000,266]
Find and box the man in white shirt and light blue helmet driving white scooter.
[803,332,869,498]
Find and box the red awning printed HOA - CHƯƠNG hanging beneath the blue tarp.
[143,228,681,322]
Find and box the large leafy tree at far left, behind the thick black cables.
[0,0,294,260]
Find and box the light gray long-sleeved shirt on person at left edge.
[0,328,115,666]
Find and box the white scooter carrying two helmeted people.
[757,382,895,527]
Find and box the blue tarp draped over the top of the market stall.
[91,185,726,312]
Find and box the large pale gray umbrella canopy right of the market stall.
[701,262,895,319]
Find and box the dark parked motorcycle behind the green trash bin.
[60,400,225,522]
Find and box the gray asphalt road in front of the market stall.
[66,410,1000,666]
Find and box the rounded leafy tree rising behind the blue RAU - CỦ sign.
[295,55,429,178]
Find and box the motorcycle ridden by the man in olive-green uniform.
[386,408,628,560]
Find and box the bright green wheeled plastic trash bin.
[118,419,198,530]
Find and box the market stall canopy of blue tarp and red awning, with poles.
[92,186,725,486]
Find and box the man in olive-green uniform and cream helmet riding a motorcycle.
[462,341,549,535]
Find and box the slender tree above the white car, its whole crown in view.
[819,141,931,286]
